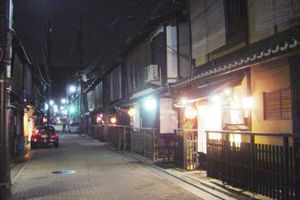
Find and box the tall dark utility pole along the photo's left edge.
[0,0,12,200]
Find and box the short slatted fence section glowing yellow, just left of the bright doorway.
[174,129,198,170]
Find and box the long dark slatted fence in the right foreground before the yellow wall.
[207,131,300,199]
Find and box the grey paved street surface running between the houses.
[12,131,225,200]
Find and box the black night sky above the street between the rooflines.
[14,0,164,97]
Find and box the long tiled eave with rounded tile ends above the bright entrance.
[170,26,300,90]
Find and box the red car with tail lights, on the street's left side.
[30,125,59,149]
